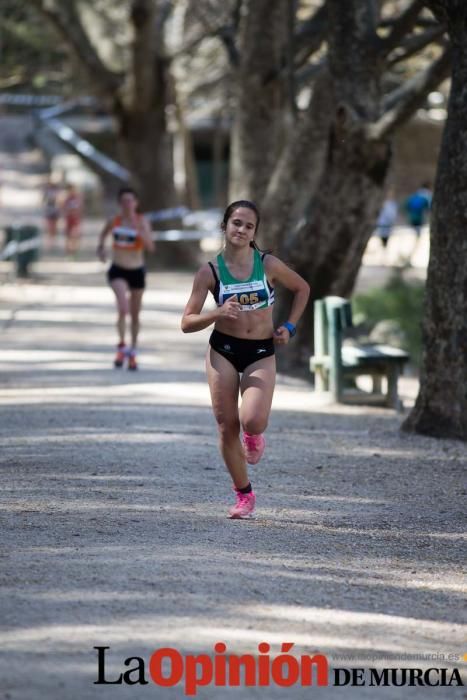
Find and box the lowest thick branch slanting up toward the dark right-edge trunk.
[368,48,452,140]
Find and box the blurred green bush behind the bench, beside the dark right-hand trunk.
[352,272,425,366]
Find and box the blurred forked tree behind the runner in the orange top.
[32,0,176,209]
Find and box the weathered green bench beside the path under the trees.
[310,296,409,411]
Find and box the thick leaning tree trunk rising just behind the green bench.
[277,0,391,372]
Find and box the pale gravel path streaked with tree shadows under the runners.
[0,117,467,700]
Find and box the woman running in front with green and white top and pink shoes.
[181,200,309,518]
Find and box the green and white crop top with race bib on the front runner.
[209,248,274,311]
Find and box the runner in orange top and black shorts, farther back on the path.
[97,187,155,370]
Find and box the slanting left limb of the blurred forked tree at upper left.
[31,0,123,97]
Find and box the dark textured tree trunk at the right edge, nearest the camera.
[404,0,467,440]
